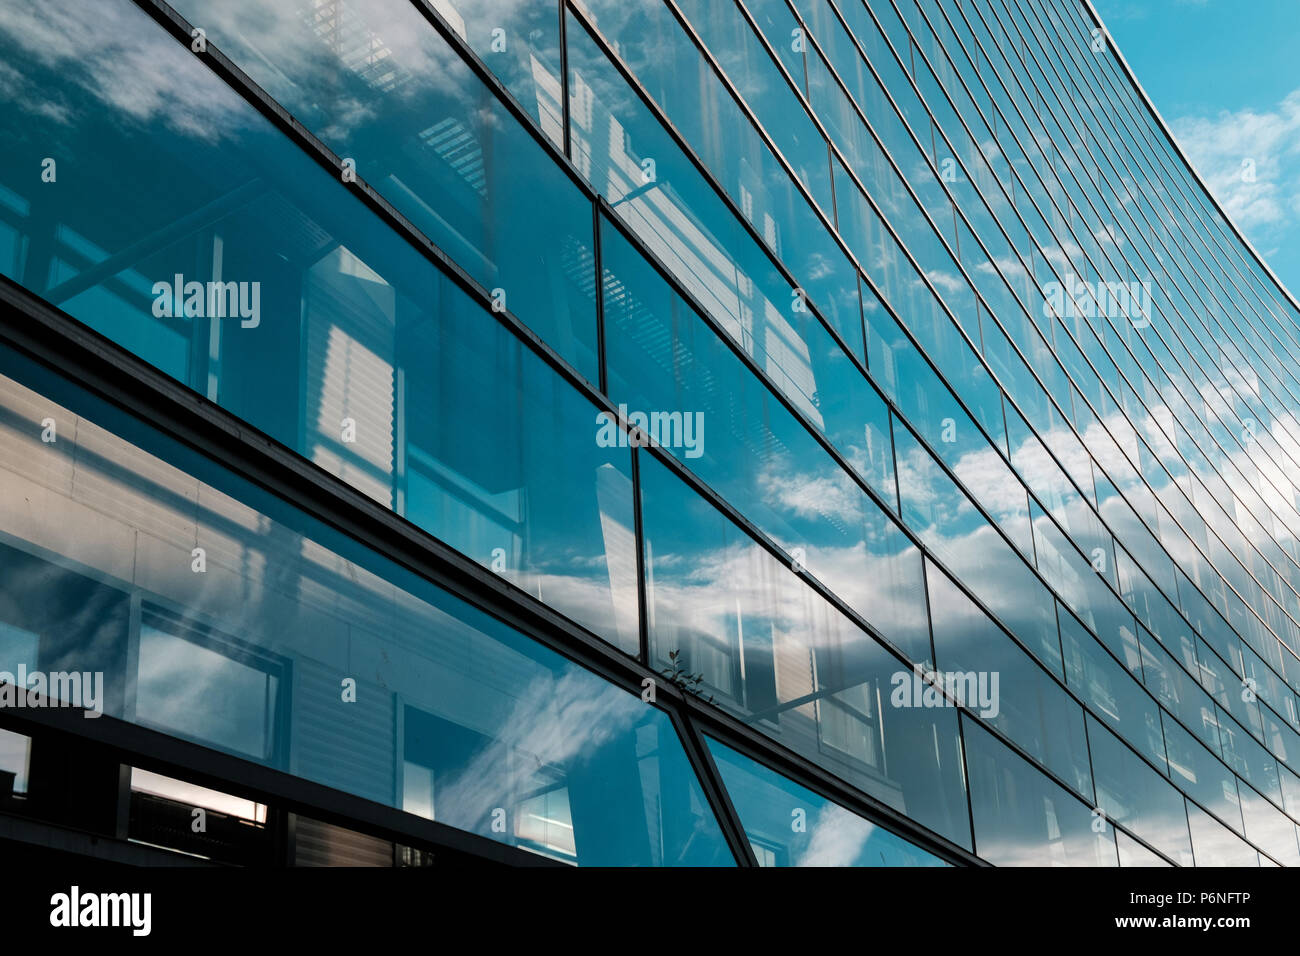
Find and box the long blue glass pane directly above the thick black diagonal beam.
[0,0,637,650]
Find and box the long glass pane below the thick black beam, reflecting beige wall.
[0,351,733,865]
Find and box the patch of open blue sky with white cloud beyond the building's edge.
[1093,0,1300,295]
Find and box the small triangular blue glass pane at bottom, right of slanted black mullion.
[706,737,946,866]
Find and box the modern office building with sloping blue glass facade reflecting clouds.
[0,0,1300,866]
